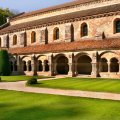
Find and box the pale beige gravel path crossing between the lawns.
[0,78,120,100]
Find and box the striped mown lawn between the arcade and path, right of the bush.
[33,78,120,93]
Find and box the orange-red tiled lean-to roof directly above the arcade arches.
[9,38,120,54]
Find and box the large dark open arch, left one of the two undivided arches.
[56,56,69,74]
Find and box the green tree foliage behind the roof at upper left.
[0,8,14,25]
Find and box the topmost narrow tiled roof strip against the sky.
[11,0,99,20]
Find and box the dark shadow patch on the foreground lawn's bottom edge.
[1,105,86,120]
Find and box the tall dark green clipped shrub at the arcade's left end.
[0,50,10,76]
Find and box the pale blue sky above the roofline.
[0,0,72,12]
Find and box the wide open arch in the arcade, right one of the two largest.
[77,55,92,75]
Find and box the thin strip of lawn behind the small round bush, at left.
[1,76,51,82]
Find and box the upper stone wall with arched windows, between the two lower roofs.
[0,15,120,47]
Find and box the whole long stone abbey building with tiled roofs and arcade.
[0,0,120,78]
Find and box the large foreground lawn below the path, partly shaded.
[0,90,120,120]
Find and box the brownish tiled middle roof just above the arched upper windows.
[0,4,120,34]
